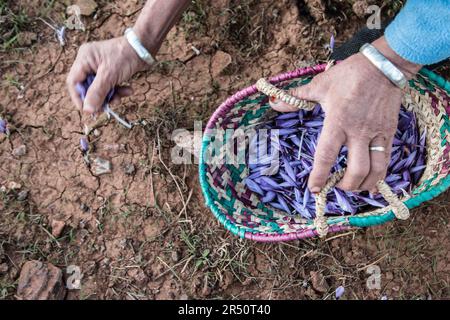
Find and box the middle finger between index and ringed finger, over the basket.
[338,139,370,191]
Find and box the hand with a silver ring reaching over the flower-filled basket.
[271,39,420,193]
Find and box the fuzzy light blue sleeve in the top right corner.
[384,0,450,65]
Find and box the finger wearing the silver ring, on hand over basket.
[360,136,392,193]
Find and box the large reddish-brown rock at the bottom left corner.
[17,260,66,300]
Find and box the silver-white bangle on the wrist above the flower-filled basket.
[359,43,408,89]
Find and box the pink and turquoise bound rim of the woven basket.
[199,64,450,242]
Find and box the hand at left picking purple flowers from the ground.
[67,37,147,114]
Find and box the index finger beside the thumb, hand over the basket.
[308,118,345,193]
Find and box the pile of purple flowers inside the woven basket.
[245,105,426,219]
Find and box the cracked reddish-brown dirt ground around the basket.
[0,0,450,299]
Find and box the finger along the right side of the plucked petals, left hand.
[83,67,114,113]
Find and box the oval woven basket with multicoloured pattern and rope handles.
[199,64,450,242]
